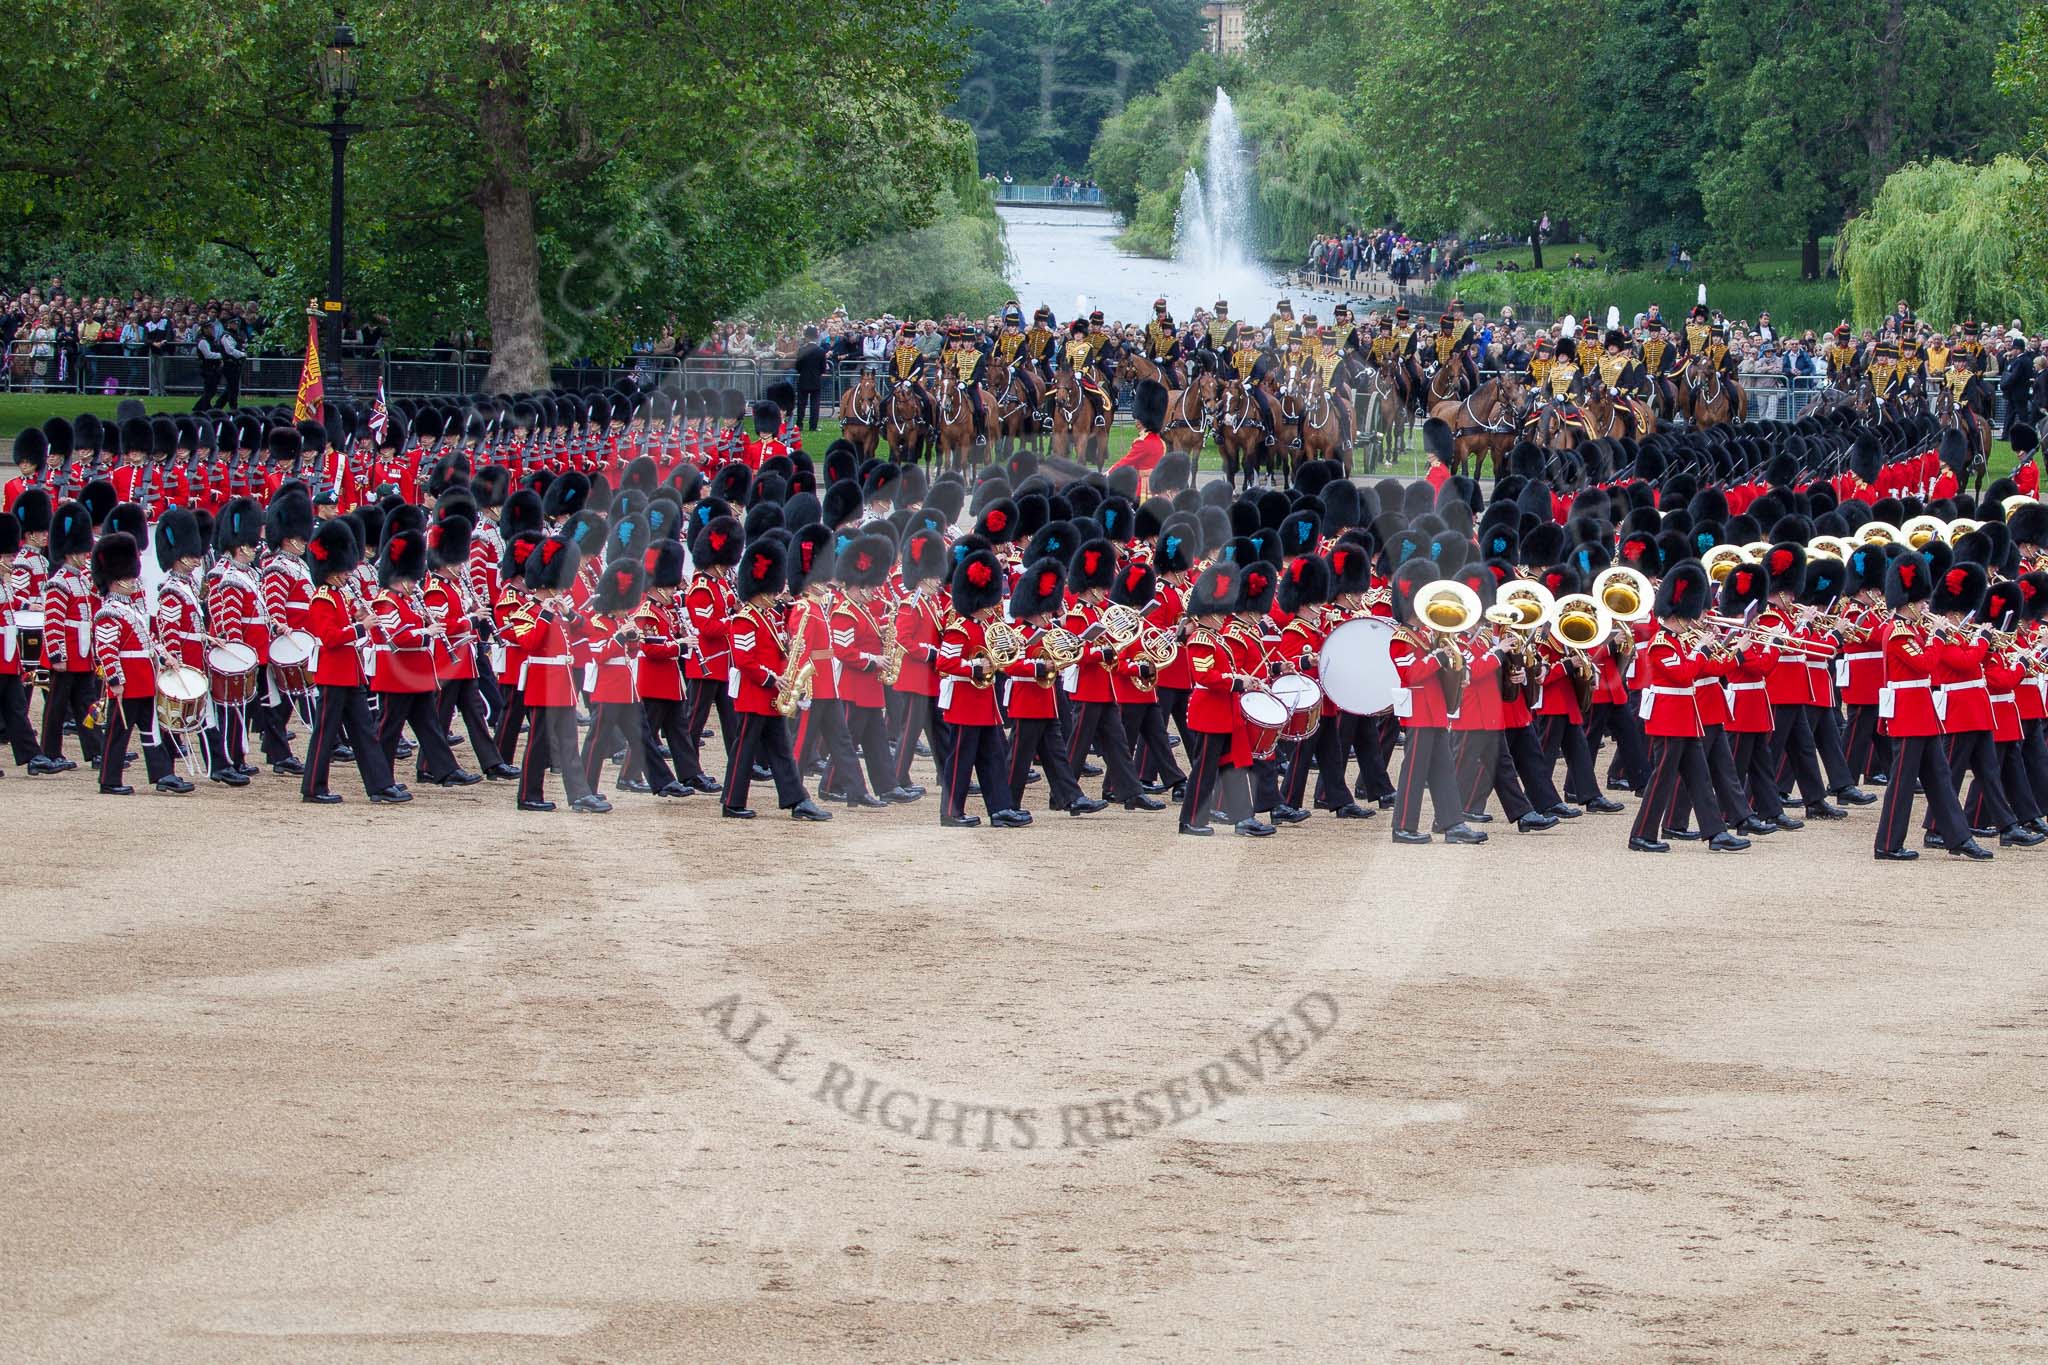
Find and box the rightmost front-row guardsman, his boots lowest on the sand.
[1876,553,1993,862]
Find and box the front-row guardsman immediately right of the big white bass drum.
[1389,559,1487,843]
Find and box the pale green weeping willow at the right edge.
[1837,156,2048,327]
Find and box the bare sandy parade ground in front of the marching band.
[0,753,2048,1363]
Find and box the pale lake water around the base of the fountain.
[997,207,1364,321]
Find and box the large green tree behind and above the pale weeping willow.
[1696,0,2013,278]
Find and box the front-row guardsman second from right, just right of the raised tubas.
[1628,559,1749,853]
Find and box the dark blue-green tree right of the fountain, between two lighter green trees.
[1577,0,1706,266]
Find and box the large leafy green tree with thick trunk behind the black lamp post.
[0,0,956,389]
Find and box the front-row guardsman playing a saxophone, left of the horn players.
[720,536,831,821]
